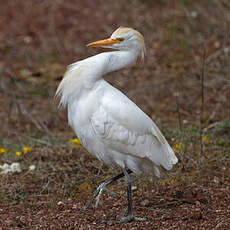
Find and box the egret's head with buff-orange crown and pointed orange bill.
[87,27,146,59]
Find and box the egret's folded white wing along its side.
[91,84,177,169]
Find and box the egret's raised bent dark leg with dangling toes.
[82,169,132,211]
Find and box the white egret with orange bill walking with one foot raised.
[56,27,178,223]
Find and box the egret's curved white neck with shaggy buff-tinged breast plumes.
[56,51,138,106]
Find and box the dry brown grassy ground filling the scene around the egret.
[0,0,230,229]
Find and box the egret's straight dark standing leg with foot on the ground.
[106,168,146,224]
